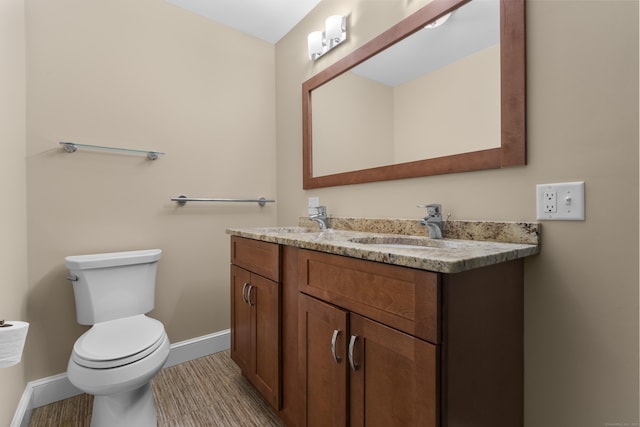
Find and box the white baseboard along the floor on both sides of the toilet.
[11,329,231,427]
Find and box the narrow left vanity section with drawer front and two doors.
[231,236,280,410]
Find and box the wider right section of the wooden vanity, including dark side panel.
[297,250,523,427]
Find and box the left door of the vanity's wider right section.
[298,294,348,427]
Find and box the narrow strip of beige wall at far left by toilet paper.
[0,0,31,426]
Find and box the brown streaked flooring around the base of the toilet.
[29,351,284,427]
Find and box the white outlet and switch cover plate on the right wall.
[536,181,584,221]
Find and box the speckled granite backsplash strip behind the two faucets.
[299,216,541,245]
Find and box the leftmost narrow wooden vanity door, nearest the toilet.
[231,265,251,375]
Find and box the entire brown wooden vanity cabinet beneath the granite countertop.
[231,236,524,427]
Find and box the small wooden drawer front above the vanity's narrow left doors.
[231,236,280,282]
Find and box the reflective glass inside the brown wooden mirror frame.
[312,0,500,175]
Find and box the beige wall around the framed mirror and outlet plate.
[276,0,639,427]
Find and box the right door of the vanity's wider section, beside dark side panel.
[348,313,439,427]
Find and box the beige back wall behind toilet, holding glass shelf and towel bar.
[26,0,277,379]
